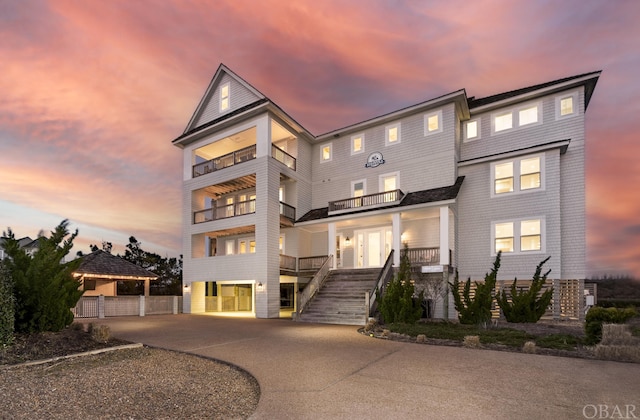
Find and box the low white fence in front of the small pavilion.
[71,296,182,318]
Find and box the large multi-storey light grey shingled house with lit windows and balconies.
[173,65,600,322]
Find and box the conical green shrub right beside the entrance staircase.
[377,244,424,324]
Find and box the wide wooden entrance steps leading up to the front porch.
[298,268,381,325]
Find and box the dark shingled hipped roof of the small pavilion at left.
[73,250,158,280]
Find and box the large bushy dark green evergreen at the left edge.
[4,220,83,333]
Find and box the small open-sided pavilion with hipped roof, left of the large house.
[73,250,158,296]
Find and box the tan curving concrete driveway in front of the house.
[92,314,640,419]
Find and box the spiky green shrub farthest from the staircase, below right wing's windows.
[496,256,553,323]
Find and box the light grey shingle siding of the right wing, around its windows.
[458,87,585,280]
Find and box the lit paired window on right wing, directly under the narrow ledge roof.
[491,155,544,196]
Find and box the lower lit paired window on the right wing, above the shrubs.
[491,218,544,254]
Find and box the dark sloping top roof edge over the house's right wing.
[468,71,602,110]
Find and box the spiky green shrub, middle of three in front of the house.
[450,252,501,325]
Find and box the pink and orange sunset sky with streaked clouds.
[0,0,640,277]
